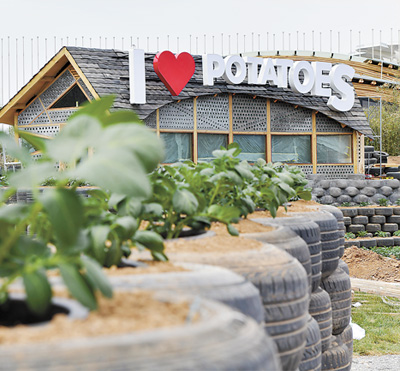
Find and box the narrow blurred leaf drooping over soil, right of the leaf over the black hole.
[59,263,97,310]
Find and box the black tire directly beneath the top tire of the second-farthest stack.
[309,288,332,352]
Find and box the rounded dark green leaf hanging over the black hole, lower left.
[22,271,52,314]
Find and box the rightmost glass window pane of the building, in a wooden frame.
[317,135,352,164]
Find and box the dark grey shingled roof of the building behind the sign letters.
[67,47,373,137]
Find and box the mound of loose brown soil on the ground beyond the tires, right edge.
[342,246,400,282]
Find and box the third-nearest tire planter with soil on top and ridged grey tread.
[168,238,309,370]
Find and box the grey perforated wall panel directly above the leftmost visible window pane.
[160,99,194,130]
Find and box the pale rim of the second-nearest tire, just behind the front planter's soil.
[109,263,264,323]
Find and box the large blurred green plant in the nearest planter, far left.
[0,97,164,313]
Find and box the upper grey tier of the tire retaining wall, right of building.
[308,174,400,206]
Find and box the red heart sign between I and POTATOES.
[153,51,195,96]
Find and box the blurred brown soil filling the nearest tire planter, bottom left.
[0,291,194,345]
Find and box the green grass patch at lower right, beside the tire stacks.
[351,292,400,356]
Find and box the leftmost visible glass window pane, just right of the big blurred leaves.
[160,133,192,164]
